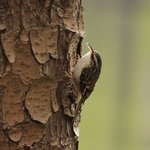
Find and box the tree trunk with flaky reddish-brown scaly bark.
[0,0,84,150]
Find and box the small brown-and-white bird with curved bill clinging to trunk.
[73,44,102,110]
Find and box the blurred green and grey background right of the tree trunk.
[79,0,150,150]
